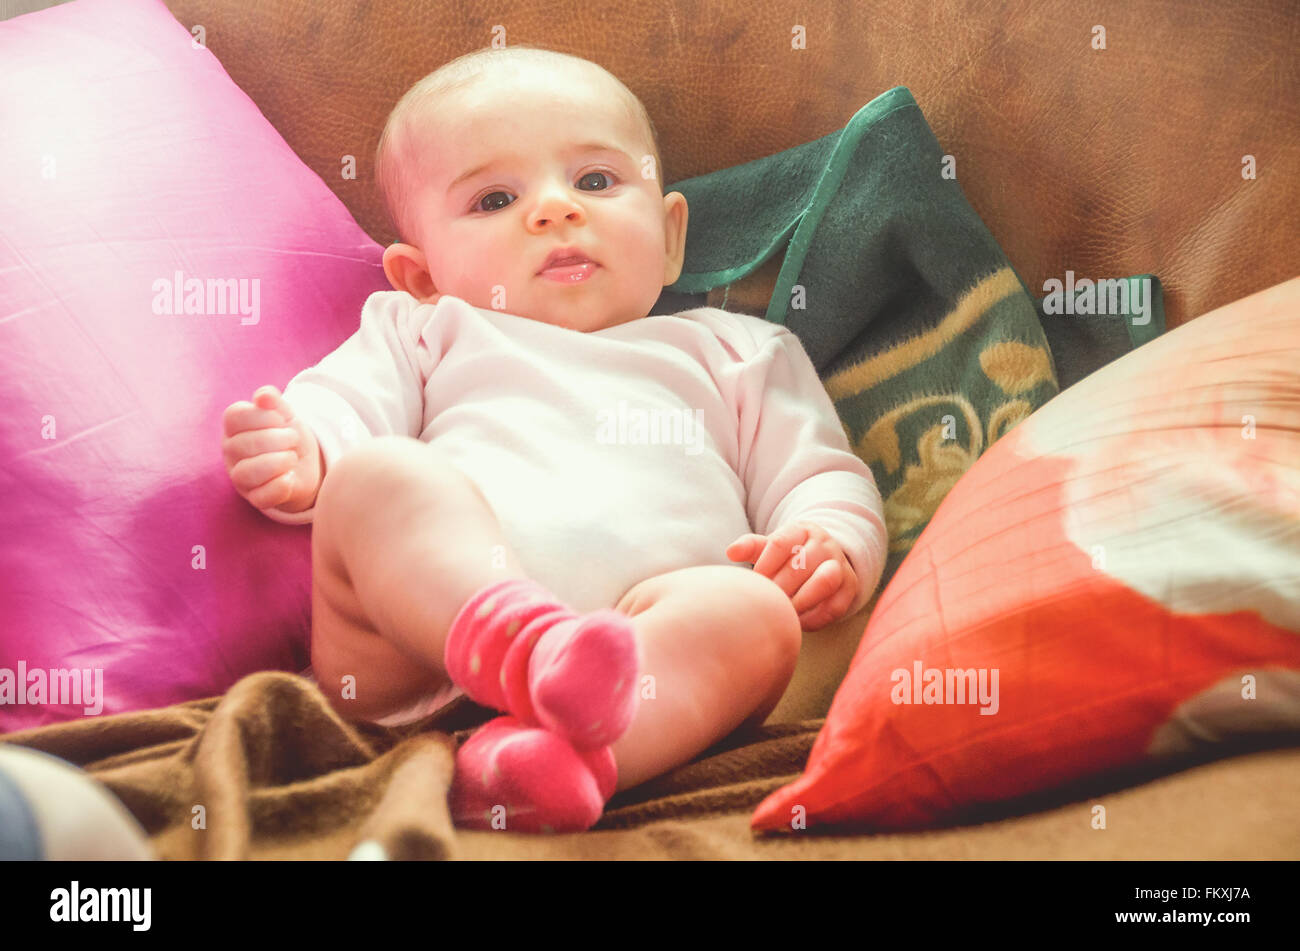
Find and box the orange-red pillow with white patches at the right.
[751,278,1300,831]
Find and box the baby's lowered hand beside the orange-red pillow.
[727,522,858,631]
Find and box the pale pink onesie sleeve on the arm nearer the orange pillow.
[738,330,888,616]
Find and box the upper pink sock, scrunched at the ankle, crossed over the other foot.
[443,578,638,750]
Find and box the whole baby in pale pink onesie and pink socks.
[222,47,887,831]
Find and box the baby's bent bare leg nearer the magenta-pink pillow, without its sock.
[312,437,525,720]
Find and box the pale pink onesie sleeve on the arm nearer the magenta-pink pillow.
[260,294,428,525]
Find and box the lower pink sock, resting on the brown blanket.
[449,717,618,833]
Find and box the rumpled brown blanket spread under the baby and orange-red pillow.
[0,672,1300,859]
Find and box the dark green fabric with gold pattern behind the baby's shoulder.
[668,87,1057,587]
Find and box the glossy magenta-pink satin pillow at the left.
[0,0,387,733]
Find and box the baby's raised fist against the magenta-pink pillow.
[221,386,324,512]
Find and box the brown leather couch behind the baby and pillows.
[147,0,1300,857]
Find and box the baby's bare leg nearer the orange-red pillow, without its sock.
[614,565,802,790]
